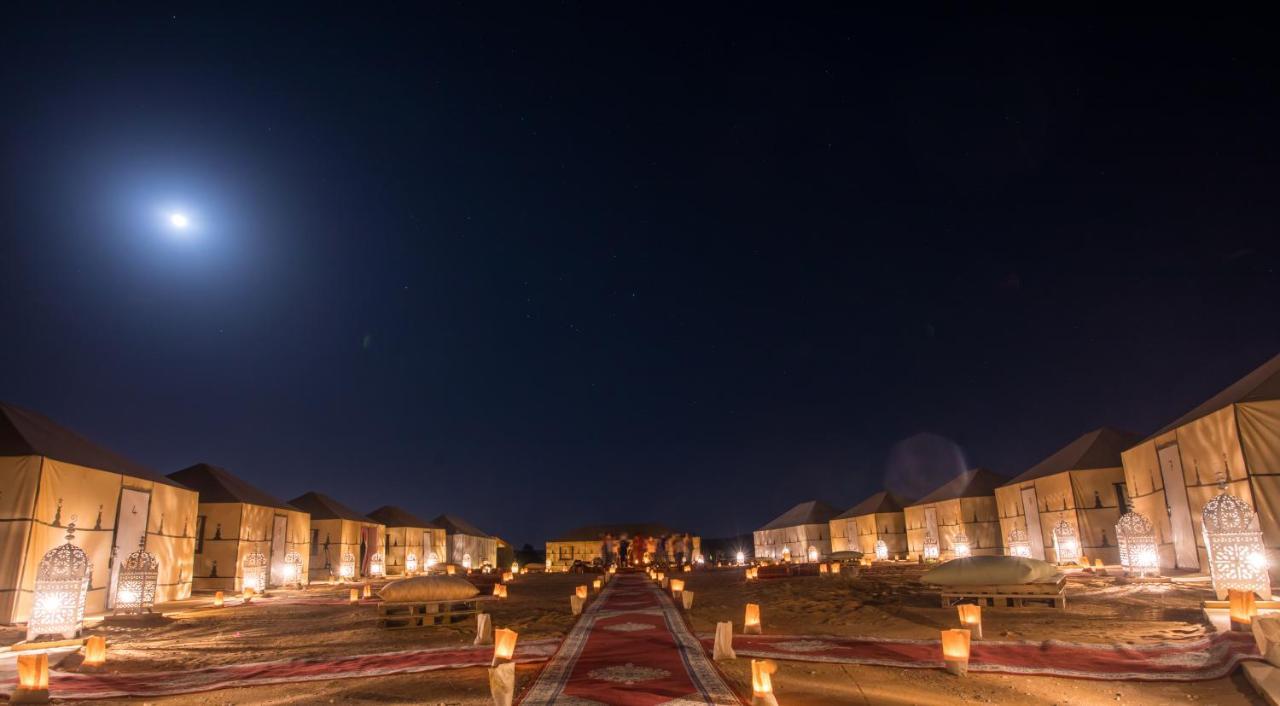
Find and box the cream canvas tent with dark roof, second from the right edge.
[996,427,1142,564]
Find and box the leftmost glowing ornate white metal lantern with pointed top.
[27,518,93,641]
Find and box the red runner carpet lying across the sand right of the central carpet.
[703,633,1262,682]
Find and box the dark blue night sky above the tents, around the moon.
[0,3,1280,546]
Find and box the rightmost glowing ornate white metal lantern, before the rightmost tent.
[1201,481,1271,600]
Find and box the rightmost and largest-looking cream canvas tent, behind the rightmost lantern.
[1121,356,1280,577]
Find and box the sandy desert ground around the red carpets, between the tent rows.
[0,569,1262,706]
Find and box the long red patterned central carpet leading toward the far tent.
[521,574,742,706]
